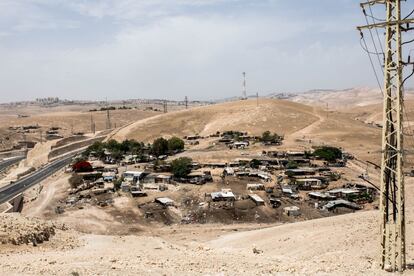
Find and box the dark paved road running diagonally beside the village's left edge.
[0,154,74,204]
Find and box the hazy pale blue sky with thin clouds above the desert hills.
[0,0,412,102]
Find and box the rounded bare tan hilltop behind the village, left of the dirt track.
[113,99,318,141]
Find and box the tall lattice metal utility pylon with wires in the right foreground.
[357,0,414,272]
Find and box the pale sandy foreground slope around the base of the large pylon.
[0,179,414,275]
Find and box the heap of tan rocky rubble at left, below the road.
[0,213,65,246]
